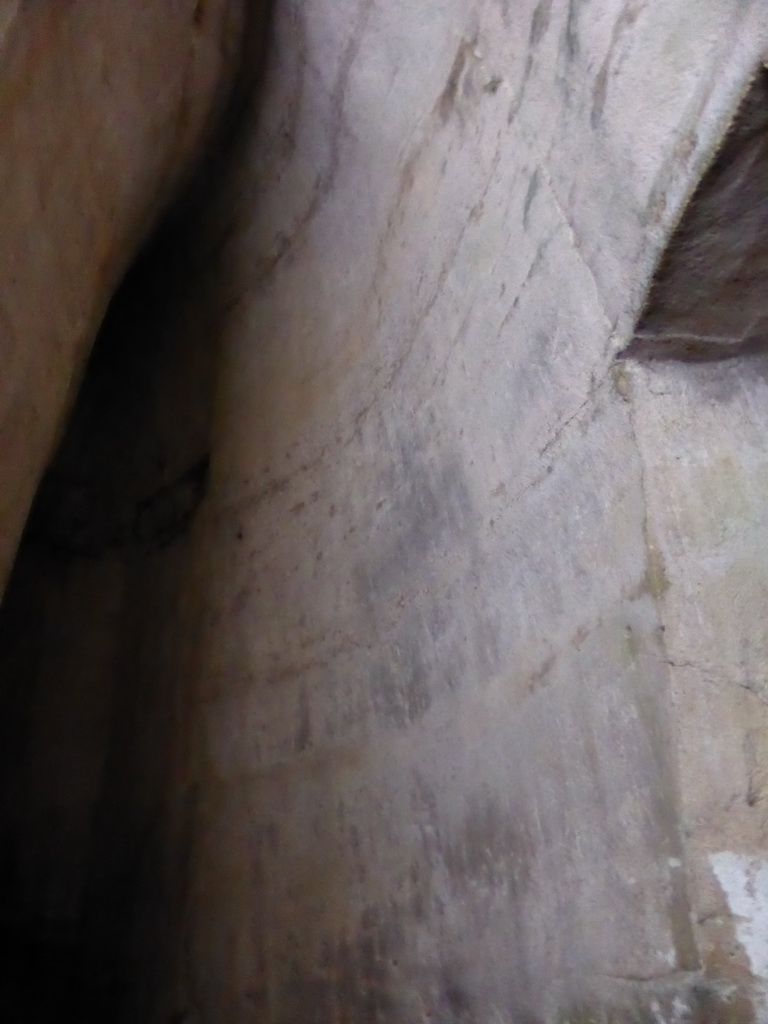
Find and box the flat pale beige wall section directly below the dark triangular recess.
[632,355,768,1020]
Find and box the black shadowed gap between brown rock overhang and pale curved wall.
[0,5,268,1024]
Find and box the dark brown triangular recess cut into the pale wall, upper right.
[622,66,768,361]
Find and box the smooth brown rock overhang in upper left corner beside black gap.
[0,0,243,591]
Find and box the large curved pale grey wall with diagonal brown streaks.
[111,2,764,1022]
